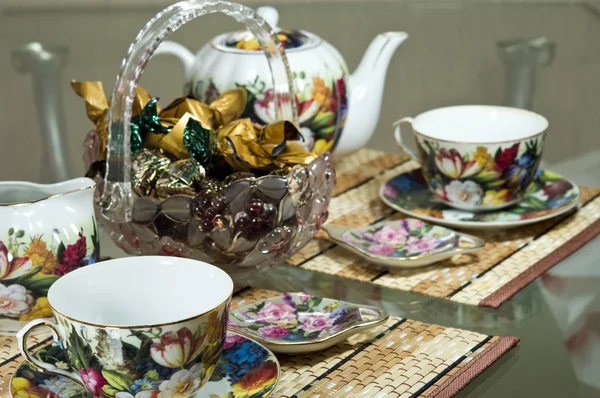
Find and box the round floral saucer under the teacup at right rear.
[379,169,579,229]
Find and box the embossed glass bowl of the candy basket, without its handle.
[106,153,335,280]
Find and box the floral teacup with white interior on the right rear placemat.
[394,105,548,211]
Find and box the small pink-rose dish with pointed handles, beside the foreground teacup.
[229,293,388,354]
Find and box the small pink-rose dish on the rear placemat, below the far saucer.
[323,218,485,268]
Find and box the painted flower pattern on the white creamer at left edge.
[0,218,100,321]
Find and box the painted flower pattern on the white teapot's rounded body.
[190,72,348,153]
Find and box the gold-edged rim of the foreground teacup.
[47,256,234,329]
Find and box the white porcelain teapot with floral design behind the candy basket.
[155,7,408,155]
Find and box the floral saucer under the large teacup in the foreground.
[10,331,280,398]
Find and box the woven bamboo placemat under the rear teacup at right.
[289,149,600,308]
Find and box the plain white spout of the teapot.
[335,32,408,155]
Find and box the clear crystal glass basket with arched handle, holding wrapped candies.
[96,0,335,283]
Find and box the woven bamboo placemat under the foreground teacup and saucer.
[0,288,519,398]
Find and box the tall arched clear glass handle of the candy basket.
[105,0,298,223]
